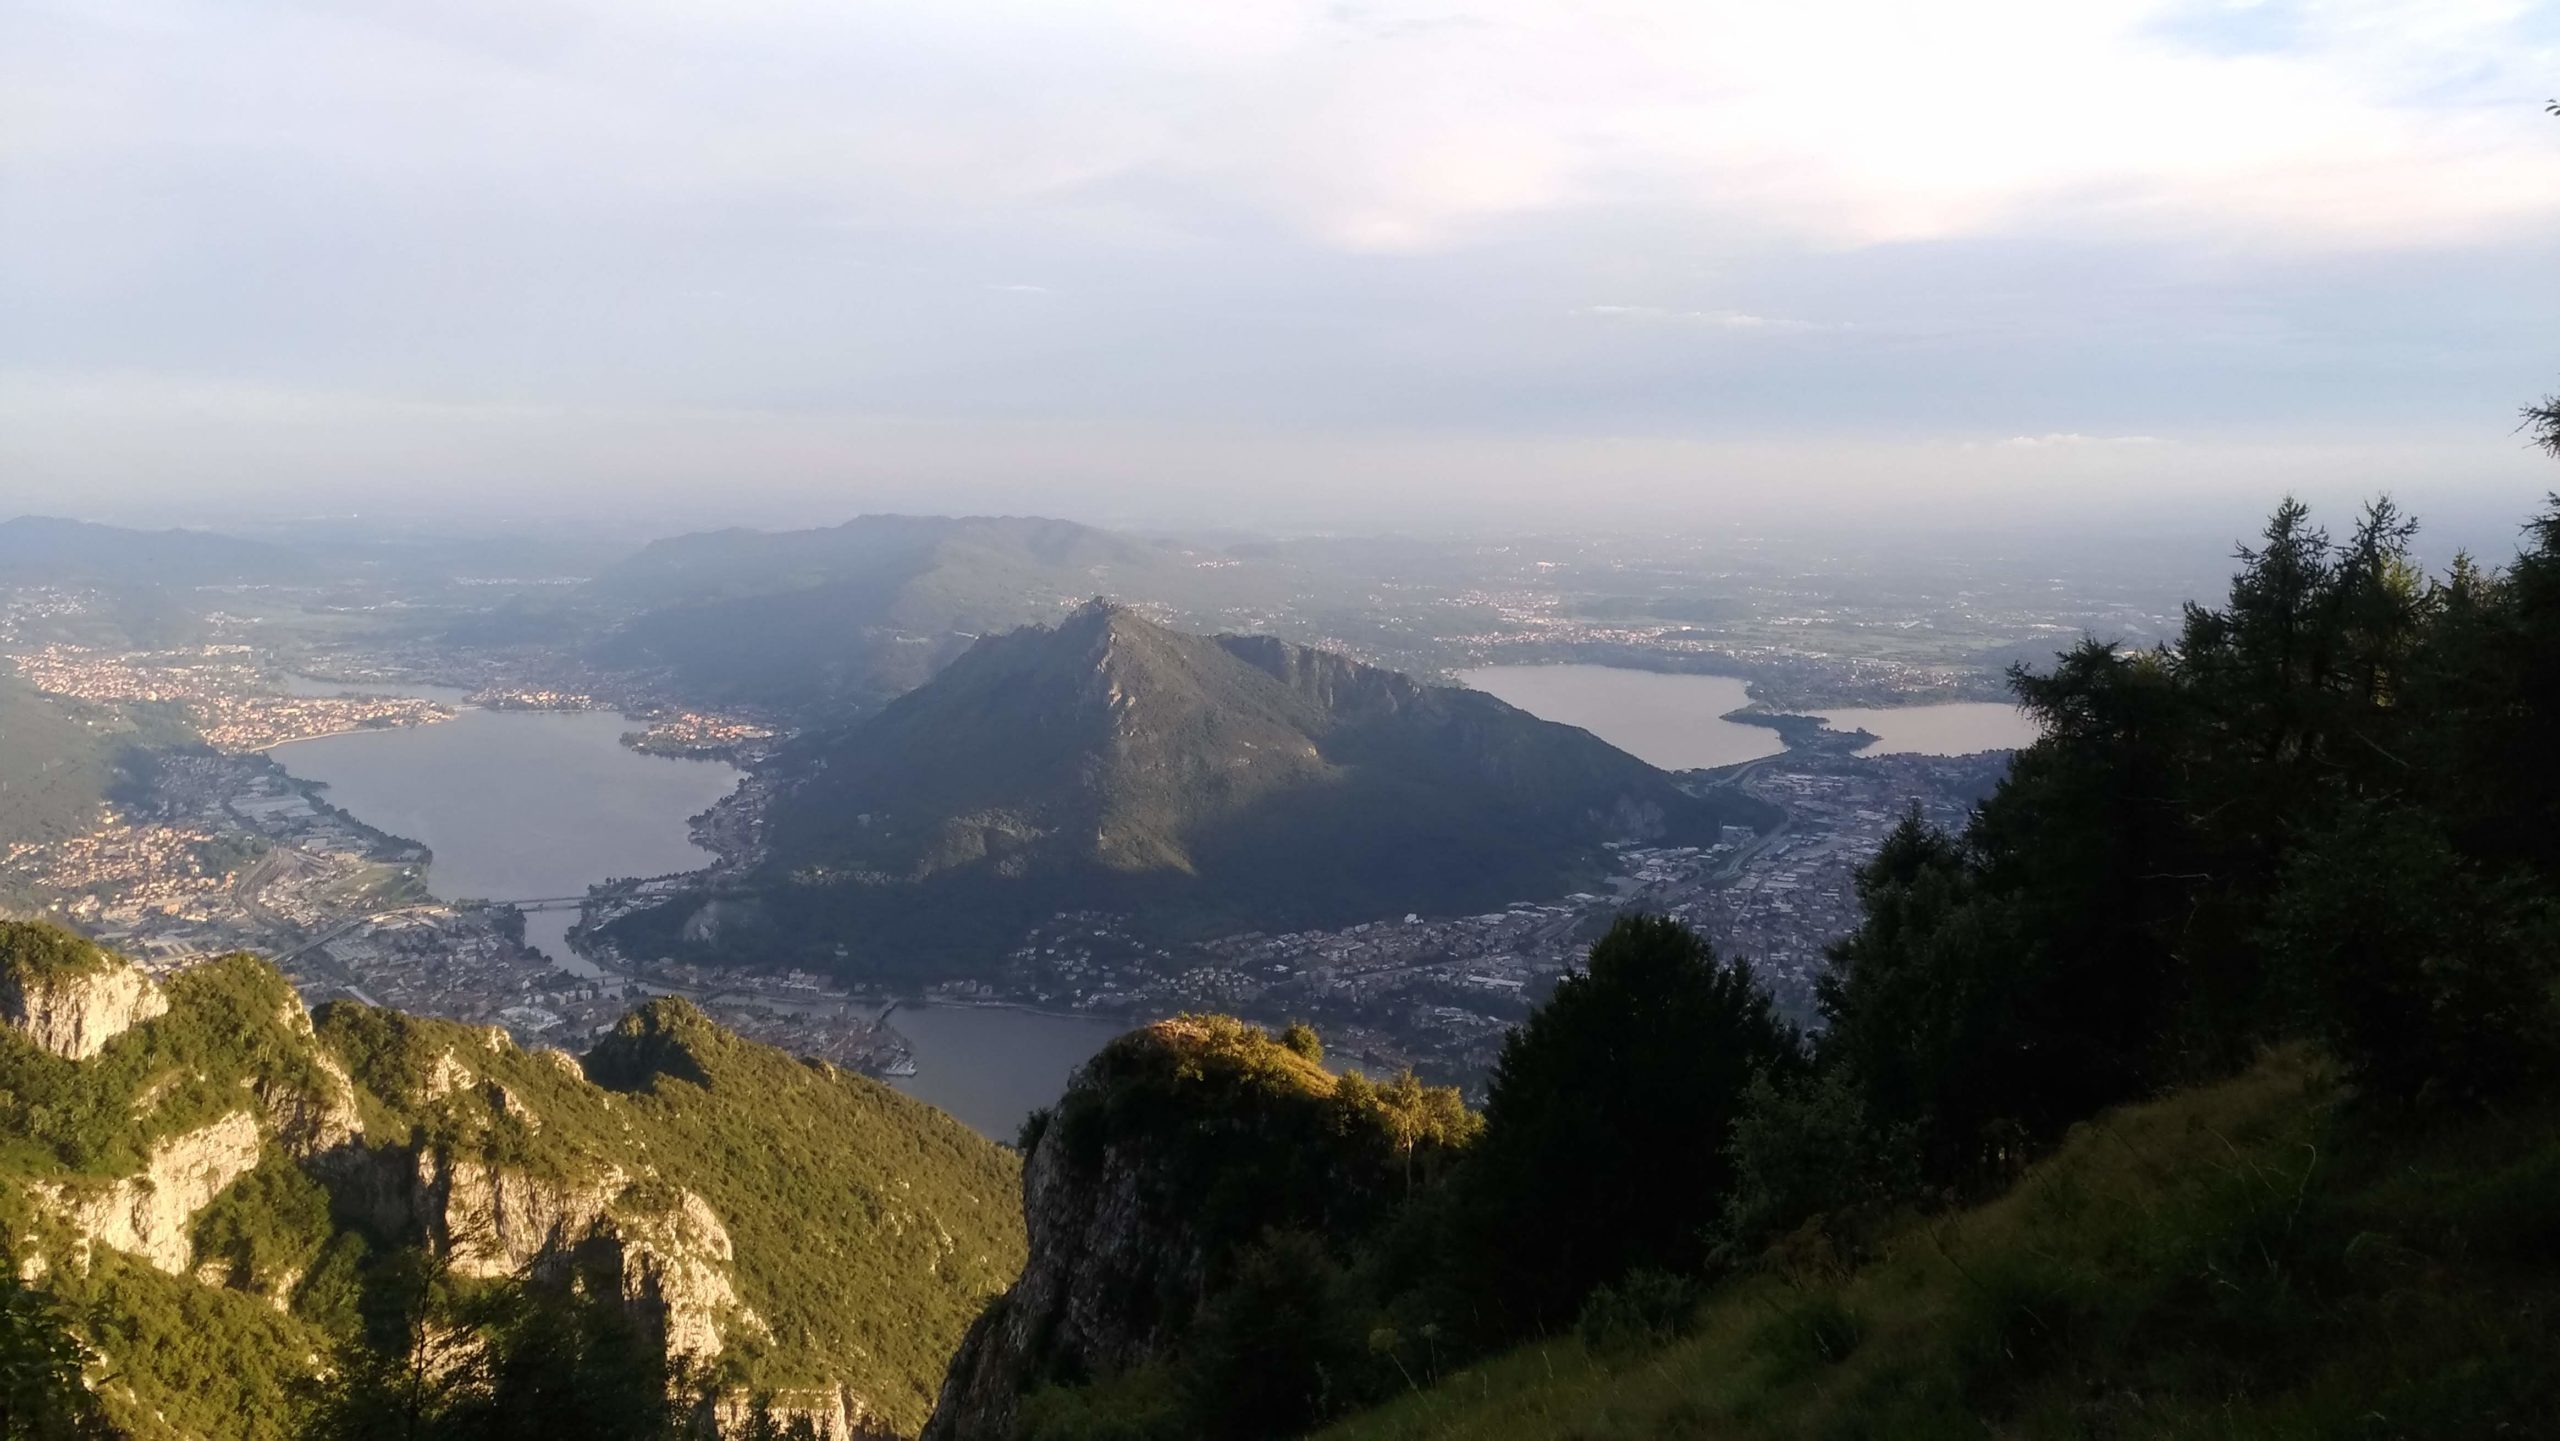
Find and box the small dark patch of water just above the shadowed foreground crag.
[888,1001,1132,1144]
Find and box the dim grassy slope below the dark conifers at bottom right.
[1326,1052,2560,1441]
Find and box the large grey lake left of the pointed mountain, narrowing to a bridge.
[269,686,740,975]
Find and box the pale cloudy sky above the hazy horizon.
[0,0,2560,542]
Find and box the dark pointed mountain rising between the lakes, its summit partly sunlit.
[627,601,1769,967]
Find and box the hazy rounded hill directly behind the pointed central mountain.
[586,514,1196,709]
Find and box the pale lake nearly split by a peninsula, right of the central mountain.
[1459,665,2035,770]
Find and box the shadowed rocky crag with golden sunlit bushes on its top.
[924,1016,1480,1441]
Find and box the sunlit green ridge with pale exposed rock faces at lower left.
[0,924,1021,1441]
